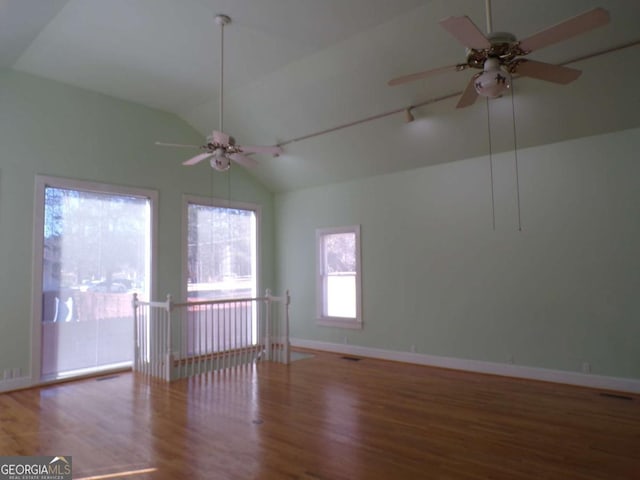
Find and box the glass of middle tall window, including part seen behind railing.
[186,203,257,355]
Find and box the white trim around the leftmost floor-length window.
[30,175,158,385]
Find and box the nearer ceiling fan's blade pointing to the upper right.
[520,7,609,53]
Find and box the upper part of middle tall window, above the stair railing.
[184,196,258,301]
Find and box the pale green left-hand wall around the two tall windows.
[0,70,274,375]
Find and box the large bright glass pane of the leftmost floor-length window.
[41,186,151,378]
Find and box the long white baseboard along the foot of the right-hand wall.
[291,338,640,393]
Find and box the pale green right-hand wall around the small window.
[275,129,640,379]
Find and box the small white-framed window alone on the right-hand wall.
[316,225,362,328]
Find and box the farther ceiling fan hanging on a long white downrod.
[156,15,282,172]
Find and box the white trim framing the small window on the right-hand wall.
[316,225,362,330]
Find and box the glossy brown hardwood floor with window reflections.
[0,353,640,480]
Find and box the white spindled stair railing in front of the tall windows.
[133,290,291,381]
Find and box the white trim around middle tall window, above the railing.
[180,195,264,302]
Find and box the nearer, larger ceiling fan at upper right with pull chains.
[388,0,609,108]
